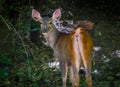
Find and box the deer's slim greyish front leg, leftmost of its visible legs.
[60,61,68,87]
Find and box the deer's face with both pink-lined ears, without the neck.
[32,9,61,33]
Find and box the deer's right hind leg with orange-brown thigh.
[80,40,92,87]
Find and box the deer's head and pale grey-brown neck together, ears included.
[32,9,61,48]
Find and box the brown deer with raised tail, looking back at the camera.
[32,9,93,87]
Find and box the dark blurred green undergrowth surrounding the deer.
[0,0,120,87]
